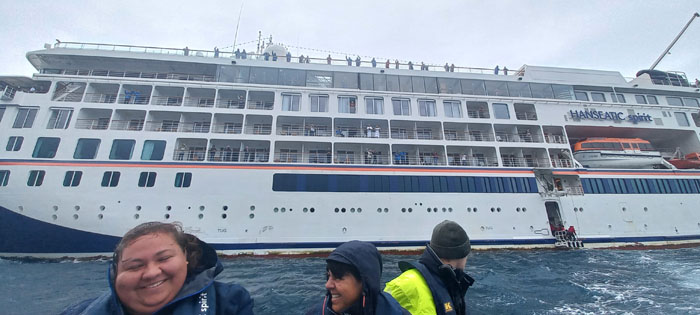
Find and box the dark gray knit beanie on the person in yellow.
[430,220,472,259]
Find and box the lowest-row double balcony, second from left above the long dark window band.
[333,143,391,165]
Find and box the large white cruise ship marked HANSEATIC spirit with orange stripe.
[0,41,700,257]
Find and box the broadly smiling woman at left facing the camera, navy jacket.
[62,222,253,315]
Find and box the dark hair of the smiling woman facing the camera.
[112,221,202,273]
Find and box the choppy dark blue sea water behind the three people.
[0,248,700,315]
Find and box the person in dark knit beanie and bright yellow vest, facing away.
[384,220,474,315]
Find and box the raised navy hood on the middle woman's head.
[326,241,382,310]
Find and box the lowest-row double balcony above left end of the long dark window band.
[274,141,333,164]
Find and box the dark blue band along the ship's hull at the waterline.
[0,207,700,254]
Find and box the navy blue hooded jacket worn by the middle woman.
[306,241,410,315]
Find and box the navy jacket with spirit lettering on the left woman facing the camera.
[61,241,253,315]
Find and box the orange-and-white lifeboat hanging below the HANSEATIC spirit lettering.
[574,138,671,169]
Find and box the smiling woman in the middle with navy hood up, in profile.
[306,241,410,315]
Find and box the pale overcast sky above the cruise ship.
[0,0,700,80]
